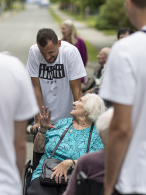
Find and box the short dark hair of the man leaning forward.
[36,28,58,47]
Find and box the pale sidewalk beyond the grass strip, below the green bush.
[51,5,117,50]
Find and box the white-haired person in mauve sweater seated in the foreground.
[63,108,114,195]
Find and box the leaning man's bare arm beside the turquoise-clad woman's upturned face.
[70,79,83,101]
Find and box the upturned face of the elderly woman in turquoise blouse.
[70,96,87,117]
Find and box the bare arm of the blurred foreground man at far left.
[14,121,27,178]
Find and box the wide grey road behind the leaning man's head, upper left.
[0,5,61,64]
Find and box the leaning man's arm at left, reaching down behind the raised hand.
[30,77,42,133]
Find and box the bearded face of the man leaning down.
[38,40,61,63]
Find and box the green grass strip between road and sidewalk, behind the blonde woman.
[49,7,99,61]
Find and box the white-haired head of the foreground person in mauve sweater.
[96,108,114,145]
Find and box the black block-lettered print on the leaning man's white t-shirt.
[39,64,65,80]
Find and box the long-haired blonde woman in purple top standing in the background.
[61,20,88,83]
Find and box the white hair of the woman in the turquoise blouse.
[84,93,106,122]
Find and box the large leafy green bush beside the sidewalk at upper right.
[96,0,132,30]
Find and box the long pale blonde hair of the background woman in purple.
[62,20,77,45]
